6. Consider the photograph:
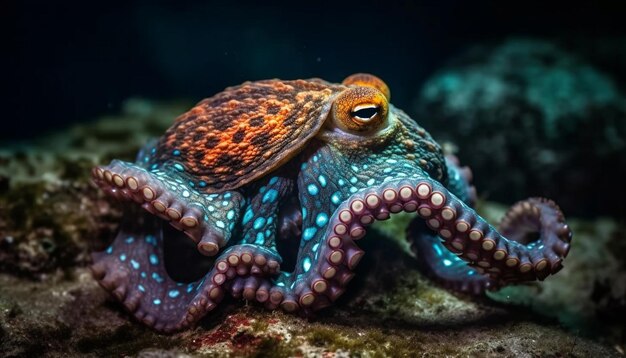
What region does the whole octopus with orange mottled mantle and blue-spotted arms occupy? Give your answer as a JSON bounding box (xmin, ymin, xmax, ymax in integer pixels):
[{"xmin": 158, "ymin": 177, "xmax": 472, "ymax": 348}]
[{"xmin": 91, "ymin": 74, "xmax": 572, "ymax": 332}]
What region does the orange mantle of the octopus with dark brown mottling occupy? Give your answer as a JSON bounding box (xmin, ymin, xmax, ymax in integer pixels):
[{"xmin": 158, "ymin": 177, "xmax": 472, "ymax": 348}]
[{"xmin": 158, "ymin": 79, "xmax": 345, "ymax": 191}]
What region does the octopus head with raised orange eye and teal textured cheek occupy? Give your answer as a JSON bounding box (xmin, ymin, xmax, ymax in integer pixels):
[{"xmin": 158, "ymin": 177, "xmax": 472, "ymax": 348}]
[{"xmin": 317, "ymin": 74, "xmax": 447, "ymax": 185}]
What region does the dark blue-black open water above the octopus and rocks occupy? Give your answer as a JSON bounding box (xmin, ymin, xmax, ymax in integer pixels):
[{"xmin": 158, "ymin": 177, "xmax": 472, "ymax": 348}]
[{"xmin": 0, "ymin": 0, "xmax": 626, "ymax": 143}]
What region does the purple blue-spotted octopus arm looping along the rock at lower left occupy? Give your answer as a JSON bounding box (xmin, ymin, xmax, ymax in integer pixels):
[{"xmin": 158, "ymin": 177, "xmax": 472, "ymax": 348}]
[{"xmin": 91, "ymin": 213, "xmax": 279, "ymax": 332}]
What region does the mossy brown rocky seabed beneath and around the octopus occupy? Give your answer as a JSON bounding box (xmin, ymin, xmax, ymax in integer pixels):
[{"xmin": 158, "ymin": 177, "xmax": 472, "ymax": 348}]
[{"xmin": 0, "ymin": 100, "xmax": 626, "ymax": 357}]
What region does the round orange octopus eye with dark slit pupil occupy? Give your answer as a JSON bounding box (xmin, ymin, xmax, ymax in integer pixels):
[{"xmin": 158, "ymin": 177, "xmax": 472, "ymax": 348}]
[{"xmin": 332, "ymin": 87, "xmax": 389, "ymax": 132}]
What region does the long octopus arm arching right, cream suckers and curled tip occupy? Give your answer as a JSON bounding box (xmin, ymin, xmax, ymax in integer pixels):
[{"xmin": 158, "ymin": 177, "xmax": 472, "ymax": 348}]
[{"xmin": 260, "ymin": 149, "xmax": 571, "ymax": 312}]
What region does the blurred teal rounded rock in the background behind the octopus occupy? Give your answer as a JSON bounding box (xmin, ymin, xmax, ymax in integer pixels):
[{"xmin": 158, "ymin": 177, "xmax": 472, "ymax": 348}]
[{"xmin": 416, "ymin": 39, "xmax": 626, "ymax": 217}]
